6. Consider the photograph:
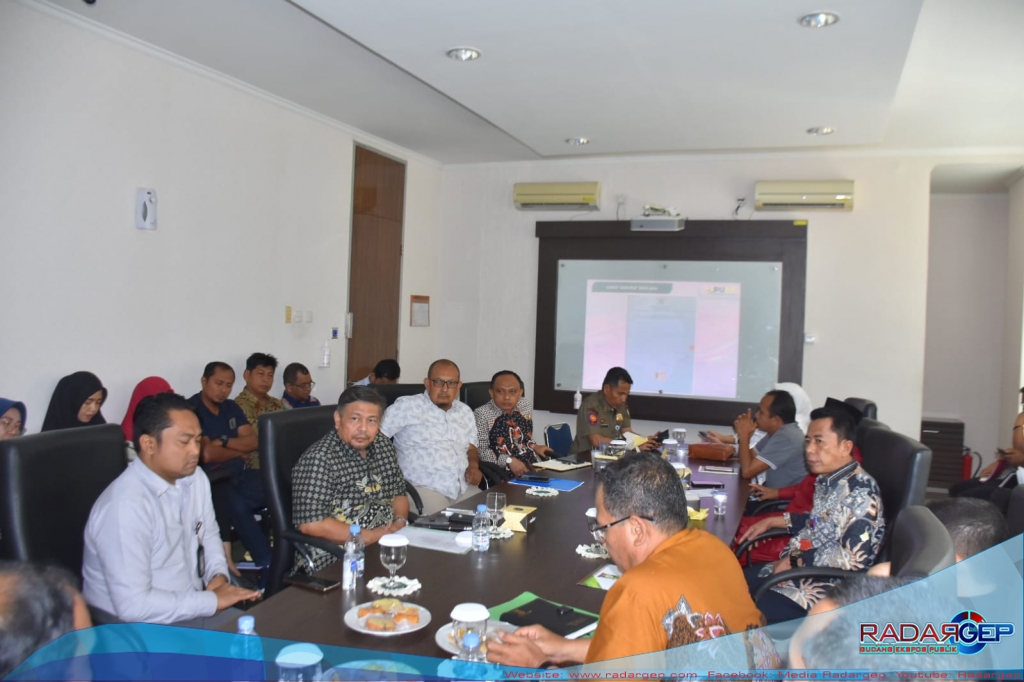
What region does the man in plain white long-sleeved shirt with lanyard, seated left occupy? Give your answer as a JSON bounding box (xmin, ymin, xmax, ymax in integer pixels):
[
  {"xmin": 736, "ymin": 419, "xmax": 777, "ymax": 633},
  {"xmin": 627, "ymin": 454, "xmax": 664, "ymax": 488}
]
[{"xmin": 82, "ymin": 393, "xmax": 259, "ymax": 626}]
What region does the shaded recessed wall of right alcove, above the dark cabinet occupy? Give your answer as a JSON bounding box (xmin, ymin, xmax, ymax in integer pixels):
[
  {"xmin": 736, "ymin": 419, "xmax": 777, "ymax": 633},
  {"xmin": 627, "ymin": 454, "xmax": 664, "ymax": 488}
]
[{"xmin": 923, "ymin": 194, "xmax": 1009, "ymax": 461}]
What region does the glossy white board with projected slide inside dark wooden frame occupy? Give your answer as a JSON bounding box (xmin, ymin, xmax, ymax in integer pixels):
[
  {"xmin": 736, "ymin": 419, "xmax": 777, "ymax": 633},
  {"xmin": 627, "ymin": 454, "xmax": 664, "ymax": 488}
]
[{"xmin": 555, "ymin": 260, "xmax": 781, "ymax": 400}]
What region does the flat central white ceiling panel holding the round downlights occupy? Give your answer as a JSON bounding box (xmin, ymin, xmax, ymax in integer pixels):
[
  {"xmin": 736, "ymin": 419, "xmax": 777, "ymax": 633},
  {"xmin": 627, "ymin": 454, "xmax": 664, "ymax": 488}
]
[{"xmin": 294, "ymin": 0, "xmax": 921, "ymax": 156}]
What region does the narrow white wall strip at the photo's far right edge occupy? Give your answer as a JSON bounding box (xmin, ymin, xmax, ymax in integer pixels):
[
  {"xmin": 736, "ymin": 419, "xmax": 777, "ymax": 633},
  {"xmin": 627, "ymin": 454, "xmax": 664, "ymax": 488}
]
[{"xmin": 999, "ymin": 178, "xmax": 1024, "ymax": 438}]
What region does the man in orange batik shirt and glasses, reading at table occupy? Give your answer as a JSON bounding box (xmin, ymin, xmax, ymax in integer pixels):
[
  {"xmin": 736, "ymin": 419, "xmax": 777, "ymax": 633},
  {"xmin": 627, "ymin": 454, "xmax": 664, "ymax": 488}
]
[{"xmin": 487, "ymin": 453, "xmax": 777, "ymax": 668}]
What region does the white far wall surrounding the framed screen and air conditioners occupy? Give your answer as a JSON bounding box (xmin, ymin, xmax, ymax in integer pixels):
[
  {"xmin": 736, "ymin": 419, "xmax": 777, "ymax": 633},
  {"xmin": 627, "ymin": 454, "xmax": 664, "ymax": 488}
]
[{"xmin": 438, "ymin": 155, "xmax": 1024, "ymax": 435}]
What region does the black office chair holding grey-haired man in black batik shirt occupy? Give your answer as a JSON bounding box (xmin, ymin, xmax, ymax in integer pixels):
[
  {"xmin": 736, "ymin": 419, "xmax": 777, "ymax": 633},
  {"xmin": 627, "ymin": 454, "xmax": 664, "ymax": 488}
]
[{"xmin": 259, "ymin": 404, "xmax": 423, "ymax": 597}]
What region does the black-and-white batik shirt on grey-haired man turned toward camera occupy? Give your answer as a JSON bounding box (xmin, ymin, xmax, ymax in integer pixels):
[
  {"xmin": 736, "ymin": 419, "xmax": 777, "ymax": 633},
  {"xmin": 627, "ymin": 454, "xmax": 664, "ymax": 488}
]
[{"xmin": 292, "ymin": 429, "xmax": 406, "ymax": 572}]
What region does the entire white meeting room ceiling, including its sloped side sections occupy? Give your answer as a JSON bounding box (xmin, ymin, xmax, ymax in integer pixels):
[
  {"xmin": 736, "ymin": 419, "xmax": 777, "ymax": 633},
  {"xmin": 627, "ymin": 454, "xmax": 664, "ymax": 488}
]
[{"xmin": 49, "ymin": 0, "xmax": 1024, "ymax": 163}]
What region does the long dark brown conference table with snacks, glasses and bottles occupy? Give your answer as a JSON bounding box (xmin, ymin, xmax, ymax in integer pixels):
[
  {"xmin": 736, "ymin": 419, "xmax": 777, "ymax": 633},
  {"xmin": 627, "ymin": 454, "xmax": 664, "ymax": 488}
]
[{"xmin": 222, "ymin": 461, "xmax": 749, "ymax": 659}]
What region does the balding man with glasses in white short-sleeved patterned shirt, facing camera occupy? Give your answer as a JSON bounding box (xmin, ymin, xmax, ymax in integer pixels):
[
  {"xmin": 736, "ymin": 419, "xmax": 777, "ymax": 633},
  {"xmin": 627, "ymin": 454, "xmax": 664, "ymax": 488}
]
[{"xmin": 381, "ymin": 359, "xmax": 483, "ymax": 514}]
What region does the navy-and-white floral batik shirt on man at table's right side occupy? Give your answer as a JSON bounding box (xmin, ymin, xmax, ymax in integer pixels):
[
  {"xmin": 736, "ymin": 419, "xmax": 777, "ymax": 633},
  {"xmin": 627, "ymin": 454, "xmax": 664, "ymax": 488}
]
[{"xmin": 772, "ymin": 461, "xmax": 886, "ymax": 609}]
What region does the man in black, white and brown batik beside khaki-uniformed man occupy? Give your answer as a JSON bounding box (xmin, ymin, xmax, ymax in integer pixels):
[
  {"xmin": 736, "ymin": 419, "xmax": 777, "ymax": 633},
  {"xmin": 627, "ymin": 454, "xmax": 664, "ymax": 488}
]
[{"xmin": 473, "ymin": 370, "xmax": 552, "ymax": 476}]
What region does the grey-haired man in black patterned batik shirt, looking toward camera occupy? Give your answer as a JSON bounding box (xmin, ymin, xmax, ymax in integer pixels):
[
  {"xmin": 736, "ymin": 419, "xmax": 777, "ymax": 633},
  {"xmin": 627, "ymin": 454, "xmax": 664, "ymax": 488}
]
[{"xmin": 292, "ymin": 386, "xmax": 409, "ymax": 572}]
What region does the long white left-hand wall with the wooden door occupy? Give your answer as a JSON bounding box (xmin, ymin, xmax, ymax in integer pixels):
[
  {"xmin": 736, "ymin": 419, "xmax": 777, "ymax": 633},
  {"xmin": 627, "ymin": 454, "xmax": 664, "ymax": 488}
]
[{"xmin": 0, "ymin": 2, "xmax": 440, "ymax": 431}]
